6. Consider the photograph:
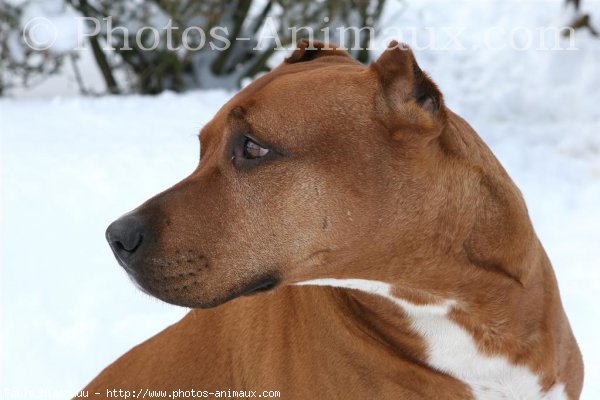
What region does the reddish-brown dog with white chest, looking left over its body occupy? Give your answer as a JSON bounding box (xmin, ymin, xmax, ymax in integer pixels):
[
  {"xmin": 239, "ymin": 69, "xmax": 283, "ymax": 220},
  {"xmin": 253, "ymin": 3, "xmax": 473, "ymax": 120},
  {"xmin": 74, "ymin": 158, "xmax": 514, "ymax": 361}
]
[{"xmin": 87, "ymin": 42, "xmax": 583, "ymax": 399}]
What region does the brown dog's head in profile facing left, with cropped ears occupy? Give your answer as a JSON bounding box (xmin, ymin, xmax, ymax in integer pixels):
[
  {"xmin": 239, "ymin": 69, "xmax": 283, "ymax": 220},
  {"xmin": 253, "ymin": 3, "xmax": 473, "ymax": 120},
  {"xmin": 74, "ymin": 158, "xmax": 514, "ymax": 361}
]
[{"xmin": 107, "ymin": 41, "xmax": 528, "ymax": 308}]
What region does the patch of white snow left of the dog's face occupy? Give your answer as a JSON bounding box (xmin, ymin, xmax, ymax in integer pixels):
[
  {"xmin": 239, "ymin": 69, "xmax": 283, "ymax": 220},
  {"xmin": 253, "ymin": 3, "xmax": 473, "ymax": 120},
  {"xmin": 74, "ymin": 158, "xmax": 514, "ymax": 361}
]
[{"xmin": 0, "ymin": 92, "xmax": 229, "ymax": 398}]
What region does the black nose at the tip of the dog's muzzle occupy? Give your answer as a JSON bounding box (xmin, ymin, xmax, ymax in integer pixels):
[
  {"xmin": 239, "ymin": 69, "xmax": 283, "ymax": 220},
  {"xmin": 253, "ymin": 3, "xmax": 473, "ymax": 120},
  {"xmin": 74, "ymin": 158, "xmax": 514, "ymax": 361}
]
[{"xmin": 106, "ymin": 215, "xmax": 147, "ymax": 264}]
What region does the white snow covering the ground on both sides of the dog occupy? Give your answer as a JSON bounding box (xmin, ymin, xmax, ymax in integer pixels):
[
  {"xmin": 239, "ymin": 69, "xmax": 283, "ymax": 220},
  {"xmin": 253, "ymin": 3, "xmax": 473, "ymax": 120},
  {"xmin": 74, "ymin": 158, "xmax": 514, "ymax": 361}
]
[{"xmin": 0, "ymin": 2, "xmax": 600, "ymax": 399}]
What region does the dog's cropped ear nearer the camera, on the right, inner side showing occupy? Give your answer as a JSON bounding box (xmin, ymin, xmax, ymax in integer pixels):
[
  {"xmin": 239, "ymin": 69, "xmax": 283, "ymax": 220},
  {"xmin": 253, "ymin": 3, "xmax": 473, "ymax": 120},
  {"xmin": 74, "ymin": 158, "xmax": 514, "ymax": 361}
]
[{"xmin": 371, "ymin": 40, "xmax": 444, "ymax": 119}]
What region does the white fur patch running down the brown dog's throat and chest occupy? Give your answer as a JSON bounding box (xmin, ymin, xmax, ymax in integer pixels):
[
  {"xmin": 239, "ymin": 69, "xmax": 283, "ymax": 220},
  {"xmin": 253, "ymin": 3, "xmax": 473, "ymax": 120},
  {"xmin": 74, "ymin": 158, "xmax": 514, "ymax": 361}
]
[{"xmin": 297, "ymin": 279, "xmax": 568, "ymax": 400}]
